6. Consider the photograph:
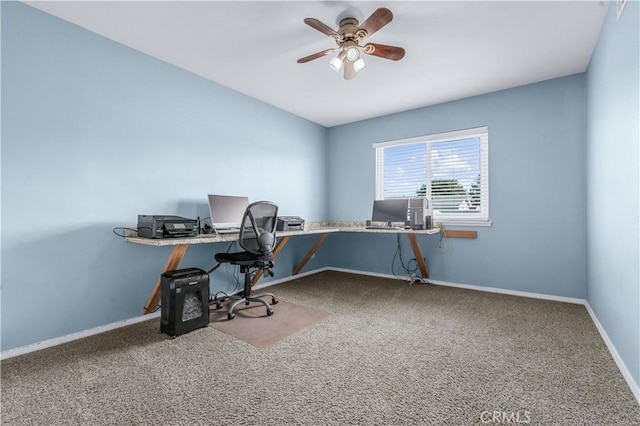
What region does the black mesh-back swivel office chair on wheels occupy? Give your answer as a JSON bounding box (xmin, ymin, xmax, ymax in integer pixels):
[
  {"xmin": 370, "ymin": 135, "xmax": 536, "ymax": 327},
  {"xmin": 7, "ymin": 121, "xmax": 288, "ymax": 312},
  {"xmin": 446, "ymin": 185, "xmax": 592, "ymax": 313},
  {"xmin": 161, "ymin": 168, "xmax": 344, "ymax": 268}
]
[{"xmin": 215, "ymin": 201, "xmax": 278, "ymax": 320}]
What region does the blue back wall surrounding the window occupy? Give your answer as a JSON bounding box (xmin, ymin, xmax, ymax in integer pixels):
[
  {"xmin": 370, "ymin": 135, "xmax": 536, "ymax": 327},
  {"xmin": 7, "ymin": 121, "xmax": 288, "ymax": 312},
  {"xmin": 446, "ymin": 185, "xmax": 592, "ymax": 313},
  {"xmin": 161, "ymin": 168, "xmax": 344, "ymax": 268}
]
[{"xmin": 328, "ymin": 74, "xmax": 586, "ymax": 298}]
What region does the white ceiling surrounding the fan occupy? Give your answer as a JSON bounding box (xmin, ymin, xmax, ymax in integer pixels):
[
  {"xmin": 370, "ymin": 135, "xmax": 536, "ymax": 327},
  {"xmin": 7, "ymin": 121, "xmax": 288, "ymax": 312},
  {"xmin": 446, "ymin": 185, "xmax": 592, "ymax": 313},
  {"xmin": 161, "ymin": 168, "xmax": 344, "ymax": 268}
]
[{"xmin": 26, "ymin": 1, "xmax": 608, "ymax": 127}]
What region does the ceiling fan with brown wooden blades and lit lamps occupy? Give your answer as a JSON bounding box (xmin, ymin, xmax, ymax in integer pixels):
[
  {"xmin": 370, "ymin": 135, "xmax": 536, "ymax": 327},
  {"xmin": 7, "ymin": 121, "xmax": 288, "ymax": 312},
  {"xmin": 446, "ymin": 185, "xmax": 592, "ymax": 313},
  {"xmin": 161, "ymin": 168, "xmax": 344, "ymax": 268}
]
[{"xmin": 297, "ymin": 7, "xmax": 404, "ymax": 80}]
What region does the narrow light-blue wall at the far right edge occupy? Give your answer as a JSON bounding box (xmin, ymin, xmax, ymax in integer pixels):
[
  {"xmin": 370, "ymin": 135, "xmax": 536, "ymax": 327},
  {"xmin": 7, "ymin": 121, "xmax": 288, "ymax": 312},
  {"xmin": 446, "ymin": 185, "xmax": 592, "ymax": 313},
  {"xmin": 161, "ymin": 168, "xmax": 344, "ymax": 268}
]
[{"xmin": 587, "ymin": 1, "xmax": 640, "ymax": 387}]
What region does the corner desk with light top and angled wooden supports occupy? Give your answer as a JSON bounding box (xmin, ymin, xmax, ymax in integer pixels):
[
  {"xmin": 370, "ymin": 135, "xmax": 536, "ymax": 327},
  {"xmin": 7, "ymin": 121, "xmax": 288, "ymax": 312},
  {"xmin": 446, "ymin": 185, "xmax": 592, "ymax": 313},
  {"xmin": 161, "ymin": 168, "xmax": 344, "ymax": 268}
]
[{"xmin": 125, "ymin": 225, "xmax": 439, "ymax": 315}]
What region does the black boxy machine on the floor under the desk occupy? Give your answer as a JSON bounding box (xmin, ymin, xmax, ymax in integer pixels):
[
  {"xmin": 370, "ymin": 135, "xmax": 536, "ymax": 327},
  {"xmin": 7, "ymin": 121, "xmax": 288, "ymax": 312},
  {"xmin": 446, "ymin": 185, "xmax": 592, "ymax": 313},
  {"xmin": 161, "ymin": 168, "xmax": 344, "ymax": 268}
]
[{"xmin": 160, "ymin": 268, "xmax": 209, "ymax": 337}]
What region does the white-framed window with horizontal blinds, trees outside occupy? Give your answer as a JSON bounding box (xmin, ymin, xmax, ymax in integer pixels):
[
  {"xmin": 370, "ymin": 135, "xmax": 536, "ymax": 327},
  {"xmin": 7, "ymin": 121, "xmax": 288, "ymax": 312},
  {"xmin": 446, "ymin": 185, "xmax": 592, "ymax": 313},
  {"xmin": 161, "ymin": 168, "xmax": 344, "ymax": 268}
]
[{"xmin": 373, "ymin": 127, "xmax": 490, "ymax": 225}]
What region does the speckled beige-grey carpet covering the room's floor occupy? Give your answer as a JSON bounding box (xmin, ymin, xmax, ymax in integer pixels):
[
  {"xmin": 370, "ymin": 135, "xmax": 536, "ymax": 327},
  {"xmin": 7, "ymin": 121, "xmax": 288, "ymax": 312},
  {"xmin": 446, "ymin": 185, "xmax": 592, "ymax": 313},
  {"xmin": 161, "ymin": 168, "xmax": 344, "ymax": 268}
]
[{"xmin": 0, "ymin": 271, "xmax": 640, "ymax": 426}]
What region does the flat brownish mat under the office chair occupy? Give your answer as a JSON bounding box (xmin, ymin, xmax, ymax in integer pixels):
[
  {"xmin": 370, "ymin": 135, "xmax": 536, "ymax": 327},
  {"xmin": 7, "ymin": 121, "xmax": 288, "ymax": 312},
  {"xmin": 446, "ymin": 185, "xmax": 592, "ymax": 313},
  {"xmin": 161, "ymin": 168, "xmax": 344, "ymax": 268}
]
[{"xmin": 209, "ymin": 300, "xmax": 331, "ymax": 348}]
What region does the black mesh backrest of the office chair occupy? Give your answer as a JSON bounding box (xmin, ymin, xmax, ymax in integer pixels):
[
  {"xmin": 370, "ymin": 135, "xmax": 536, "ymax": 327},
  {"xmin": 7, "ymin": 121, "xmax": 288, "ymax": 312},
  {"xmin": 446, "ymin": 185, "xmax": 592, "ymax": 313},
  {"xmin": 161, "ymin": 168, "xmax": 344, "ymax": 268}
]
[{"xmin": 239, "ymin": 201, "xmax": 278, "ymax": 260}]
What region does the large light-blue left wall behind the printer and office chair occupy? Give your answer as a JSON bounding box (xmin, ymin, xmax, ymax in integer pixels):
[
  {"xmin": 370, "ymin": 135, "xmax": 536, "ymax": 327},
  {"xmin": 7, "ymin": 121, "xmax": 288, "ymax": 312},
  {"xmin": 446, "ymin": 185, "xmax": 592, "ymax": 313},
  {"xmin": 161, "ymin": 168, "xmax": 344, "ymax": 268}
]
[{"xmin": 1, "ymin": 2, "xmax": 327, "ymax": 350}]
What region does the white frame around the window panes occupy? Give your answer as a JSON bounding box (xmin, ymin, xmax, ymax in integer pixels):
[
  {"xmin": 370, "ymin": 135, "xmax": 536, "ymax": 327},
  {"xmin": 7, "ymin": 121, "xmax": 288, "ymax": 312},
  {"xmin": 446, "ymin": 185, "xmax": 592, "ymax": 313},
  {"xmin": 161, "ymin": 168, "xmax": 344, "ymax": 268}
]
[{"xmin": 373, "ymin": 126, "xmax": 491, "ymax": 226}]
